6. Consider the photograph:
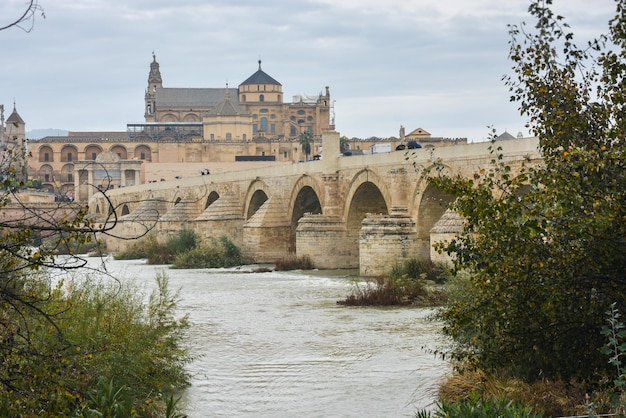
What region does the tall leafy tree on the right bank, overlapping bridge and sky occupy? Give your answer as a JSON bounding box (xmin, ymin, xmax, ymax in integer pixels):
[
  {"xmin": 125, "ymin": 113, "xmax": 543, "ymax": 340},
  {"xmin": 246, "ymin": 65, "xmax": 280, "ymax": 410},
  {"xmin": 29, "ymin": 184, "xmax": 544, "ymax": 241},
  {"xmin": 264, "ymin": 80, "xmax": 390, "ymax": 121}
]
[{"xmin": 429, "ymin": 0, "xmax": 626, "ymax": 384}]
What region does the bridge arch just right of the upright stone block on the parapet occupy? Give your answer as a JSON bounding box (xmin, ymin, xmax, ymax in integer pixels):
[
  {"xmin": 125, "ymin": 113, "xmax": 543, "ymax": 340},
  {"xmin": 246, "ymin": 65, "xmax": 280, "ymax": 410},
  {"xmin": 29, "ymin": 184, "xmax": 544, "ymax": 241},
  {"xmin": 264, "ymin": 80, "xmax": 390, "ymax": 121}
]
[{"xmin": 344, "ymin": 169, "xmax": 391, "ymax": 266}]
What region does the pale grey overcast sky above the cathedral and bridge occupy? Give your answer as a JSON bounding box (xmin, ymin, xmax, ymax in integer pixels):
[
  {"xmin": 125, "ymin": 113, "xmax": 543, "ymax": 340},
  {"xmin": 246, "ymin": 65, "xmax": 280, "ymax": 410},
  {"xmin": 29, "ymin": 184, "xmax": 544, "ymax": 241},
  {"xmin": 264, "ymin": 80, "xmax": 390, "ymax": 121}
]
[{"xmin": 0, "ymin": 0, "xmax": 615, "ymax": 141}]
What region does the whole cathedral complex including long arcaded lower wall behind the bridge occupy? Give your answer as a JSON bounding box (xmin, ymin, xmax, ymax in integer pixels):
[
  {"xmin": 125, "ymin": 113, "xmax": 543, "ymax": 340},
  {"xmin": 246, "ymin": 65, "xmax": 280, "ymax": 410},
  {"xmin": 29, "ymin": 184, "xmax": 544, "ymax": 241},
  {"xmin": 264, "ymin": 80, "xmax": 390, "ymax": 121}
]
[{"xmin": 28, "ymin": 54, "xmax": 334, "ymax": 200}]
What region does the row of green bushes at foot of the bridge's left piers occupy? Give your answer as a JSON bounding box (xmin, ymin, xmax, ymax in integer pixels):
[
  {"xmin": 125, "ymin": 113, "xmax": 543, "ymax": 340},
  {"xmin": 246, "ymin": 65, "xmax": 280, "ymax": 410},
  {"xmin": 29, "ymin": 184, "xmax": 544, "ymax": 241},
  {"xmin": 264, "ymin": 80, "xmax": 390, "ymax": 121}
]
[{"xmin": 115, "ymin": 229, "xmax": 245, "ymax": 269}]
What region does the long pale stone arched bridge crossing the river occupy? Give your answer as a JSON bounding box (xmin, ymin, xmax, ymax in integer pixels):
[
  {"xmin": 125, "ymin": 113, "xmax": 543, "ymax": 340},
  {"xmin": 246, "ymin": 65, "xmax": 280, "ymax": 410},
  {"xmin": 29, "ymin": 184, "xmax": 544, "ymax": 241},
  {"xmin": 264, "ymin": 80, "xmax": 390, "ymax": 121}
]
[{"xmin": 89, "ymin": 132, "xmax": 541, "ymax": 276}]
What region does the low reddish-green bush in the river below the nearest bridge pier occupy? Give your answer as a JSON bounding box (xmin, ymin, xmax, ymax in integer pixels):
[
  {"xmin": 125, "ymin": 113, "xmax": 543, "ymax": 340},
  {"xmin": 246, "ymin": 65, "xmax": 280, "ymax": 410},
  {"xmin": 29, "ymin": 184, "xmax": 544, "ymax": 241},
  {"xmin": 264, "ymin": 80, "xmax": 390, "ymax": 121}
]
[{"xmin": 337, "ymin": 259, "xmax": 447, "ymax": 306}]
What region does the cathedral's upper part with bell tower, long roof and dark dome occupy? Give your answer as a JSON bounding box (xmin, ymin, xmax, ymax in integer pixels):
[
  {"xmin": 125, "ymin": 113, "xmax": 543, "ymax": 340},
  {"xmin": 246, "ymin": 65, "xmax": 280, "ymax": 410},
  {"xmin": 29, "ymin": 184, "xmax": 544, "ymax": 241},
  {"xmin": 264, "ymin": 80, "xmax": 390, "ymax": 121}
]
[{"xmin": 144, "ymin": 55, "xmax": 331, "ymax": 142}]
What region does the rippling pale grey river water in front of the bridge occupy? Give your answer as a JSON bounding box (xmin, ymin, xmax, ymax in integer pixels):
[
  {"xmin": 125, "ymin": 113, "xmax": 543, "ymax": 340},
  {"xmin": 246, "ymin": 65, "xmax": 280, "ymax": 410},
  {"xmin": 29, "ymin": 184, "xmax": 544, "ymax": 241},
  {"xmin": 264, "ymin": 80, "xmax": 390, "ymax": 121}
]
[{"xmin": 84, "ymin": 259, "xmax": 449, "ymax": 418}]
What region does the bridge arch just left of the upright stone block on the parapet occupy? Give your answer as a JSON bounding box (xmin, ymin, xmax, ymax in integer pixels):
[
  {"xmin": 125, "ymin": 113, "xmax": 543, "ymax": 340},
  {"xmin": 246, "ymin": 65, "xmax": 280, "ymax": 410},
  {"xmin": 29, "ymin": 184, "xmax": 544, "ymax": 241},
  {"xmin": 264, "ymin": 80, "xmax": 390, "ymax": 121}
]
[{"xmin": 288, "ymin": 175, "xmax": 324, "ymax": 253}]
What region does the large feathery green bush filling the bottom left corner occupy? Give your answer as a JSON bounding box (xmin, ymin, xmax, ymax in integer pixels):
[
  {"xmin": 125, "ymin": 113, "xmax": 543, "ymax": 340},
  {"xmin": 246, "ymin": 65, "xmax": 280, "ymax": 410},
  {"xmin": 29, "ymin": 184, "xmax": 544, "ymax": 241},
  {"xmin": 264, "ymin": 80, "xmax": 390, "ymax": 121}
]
[{"xmin": 0, "ymin": 274, "xmax": 191, "ymax": 417}]
